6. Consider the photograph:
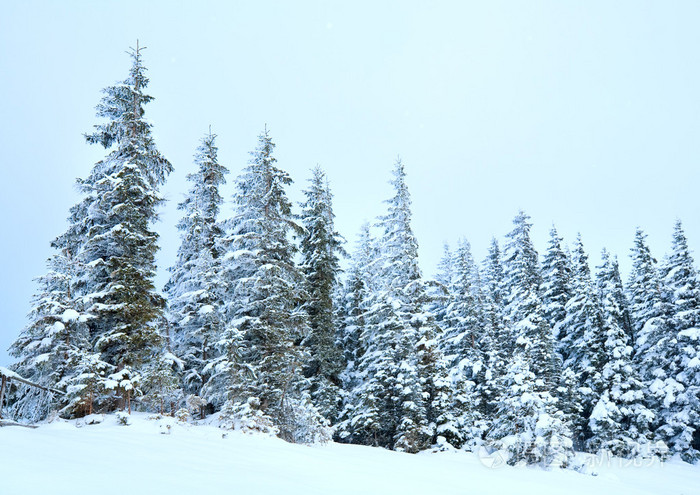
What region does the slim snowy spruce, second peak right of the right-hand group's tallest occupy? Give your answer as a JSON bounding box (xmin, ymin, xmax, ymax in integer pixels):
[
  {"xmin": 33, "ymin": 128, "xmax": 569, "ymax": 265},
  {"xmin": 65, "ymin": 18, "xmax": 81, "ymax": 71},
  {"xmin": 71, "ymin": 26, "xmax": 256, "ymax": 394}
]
[{"xmin": 560, "ymin": 235, "xmax": 605, "ymax": 445}]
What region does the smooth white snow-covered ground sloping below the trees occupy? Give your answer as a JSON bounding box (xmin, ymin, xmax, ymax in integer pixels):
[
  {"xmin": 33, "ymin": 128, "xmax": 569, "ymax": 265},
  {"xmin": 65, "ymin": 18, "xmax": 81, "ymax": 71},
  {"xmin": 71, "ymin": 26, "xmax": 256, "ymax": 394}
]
[{"xmin": 0, "ymin": 414, "xmax": 700, "ymax": 495}]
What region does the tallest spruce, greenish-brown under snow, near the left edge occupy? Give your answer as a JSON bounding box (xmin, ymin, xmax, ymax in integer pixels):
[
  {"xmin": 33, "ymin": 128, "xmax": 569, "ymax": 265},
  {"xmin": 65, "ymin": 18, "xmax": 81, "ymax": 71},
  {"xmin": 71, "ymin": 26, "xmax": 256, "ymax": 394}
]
[{"xmin": 54, "ymin": 45, "xmax": 172, "ymax": 412}]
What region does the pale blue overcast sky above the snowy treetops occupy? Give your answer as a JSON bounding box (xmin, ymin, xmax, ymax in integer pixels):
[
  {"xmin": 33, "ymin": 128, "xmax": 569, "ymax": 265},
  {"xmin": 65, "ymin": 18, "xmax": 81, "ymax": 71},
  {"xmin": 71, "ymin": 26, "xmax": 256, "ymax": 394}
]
[{"xmin": 0, "ymin": 0, "xmax": 700, "ymax": 365}]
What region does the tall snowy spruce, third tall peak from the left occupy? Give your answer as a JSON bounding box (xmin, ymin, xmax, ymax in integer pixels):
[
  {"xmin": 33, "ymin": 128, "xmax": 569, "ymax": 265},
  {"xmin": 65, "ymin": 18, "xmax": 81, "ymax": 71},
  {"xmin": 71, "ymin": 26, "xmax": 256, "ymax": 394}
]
[{"xmin": 223, "ymin": 129, "xmax": 325, "ymax": 441}]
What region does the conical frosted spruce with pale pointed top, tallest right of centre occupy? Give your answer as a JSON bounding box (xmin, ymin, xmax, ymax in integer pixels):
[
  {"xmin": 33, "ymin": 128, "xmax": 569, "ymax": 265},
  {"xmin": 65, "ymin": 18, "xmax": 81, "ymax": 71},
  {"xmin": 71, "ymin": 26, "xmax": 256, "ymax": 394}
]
[{"xmin": 340, "ymin": 160, "xmax": 451, "ymax": 452}]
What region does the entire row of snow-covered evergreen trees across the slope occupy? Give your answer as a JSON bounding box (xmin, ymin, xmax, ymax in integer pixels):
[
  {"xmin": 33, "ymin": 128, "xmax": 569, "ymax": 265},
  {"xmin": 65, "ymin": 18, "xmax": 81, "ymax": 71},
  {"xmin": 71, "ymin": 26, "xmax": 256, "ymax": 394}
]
[{"xmin": 5, "ymin": 47, "xmax": 700, "ymax": 465}]
